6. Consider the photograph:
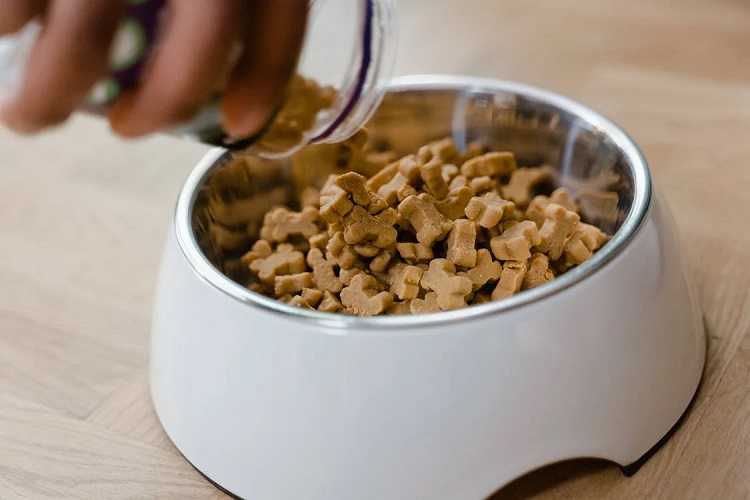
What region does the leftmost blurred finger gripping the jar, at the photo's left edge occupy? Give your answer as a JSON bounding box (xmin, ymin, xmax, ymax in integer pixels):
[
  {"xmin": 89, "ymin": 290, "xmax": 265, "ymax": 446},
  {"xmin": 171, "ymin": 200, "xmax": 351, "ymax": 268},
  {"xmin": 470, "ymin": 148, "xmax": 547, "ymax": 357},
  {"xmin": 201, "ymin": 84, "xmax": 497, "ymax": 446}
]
[{"xmin": 0, "ymin": 0, "xmax": 124, "ymax": 133}]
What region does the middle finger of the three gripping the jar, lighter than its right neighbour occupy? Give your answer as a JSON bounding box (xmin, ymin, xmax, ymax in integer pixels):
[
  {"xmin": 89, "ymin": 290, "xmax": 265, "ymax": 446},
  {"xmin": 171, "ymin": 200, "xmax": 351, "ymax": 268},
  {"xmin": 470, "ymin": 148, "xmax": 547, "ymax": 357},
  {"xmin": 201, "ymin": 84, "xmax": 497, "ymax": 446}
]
[{"xmin": 110, "ymin": 0, "xmax": 246, "ymax": 137}]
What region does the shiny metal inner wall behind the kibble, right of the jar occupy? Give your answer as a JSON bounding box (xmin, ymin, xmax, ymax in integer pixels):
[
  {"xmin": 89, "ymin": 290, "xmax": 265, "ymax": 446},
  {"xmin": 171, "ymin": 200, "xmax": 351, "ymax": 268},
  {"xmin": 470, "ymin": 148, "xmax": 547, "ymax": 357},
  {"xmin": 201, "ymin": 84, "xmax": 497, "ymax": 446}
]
[{"xmin": 368, "ymin": 83, "xmax": 636, "ymax": 235}]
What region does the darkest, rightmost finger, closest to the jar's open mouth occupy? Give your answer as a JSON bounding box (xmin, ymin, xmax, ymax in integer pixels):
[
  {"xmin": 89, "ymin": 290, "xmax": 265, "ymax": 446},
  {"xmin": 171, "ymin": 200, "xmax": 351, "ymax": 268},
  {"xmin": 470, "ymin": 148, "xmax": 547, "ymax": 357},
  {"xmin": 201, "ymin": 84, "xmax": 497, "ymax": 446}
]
[{"xmin": 222, "ymin": 0, "xmax": 308, "ymax": 138}]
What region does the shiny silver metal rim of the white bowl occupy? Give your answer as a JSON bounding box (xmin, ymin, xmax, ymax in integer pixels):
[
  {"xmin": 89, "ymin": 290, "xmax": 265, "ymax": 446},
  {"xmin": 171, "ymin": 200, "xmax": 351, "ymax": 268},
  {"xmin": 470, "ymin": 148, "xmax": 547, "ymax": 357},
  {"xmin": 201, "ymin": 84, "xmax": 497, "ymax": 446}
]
[{"xmin": 174, "ymin": 75, "xmax": 652, "ymax": 333}]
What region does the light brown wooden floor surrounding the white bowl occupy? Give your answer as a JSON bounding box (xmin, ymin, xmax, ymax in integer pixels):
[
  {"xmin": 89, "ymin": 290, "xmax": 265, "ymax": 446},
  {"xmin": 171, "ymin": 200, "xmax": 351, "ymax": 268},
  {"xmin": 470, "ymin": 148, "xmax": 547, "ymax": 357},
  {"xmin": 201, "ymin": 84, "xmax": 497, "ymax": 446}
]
[{"xmin": 0, "ymin": 0, "xmax": 750, "ymax": 499}]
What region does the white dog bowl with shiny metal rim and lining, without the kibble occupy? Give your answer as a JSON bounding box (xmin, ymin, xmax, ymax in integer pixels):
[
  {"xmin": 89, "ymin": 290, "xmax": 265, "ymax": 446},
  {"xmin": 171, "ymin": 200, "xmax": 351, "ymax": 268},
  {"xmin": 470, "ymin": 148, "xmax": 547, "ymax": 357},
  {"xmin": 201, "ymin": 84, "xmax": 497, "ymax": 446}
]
[{"xmin": 151, "ymin": 77, "xmax": 705, "ymax": 500}]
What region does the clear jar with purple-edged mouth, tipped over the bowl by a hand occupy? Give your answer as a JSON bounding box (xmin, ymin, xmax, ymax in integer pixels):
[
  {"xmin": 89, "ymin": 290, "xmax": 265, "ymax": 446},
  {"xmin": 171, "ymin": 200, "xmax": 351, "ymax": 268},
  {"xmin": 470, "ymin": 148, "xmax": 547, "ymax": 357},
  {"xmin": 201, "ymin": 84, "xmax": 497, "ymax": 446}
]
[{"xmin": 0, "ymin": 0, "xmax": 395, "ymax": 158}]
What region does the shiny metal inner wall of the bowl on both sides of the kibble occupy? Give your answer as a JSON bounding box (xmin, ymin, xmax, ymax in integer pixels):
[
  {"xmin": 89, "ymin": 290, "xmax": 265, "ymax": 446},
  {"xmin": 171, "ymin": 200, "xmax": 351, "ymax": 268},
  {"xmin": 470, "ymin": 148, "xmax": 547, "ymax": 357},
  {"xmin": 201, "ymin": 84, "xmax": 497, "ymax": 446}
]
[{"xmin": 178, "ymin": 78, "xmax": 650, "ymax": 322}]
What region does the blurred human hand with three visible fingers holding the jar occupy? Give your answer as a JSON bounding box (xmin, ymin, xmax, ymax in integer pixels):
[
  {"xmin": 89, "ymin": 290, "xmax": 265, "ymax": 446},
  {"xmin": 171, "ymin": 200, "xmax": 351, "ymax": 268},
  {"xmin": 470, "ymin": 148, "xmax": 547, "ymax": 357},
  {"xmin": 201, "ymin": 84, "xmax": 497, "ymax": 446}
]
[{"xmin": 0, "ymin": 0, "xmax": 308, "ymax": 137}]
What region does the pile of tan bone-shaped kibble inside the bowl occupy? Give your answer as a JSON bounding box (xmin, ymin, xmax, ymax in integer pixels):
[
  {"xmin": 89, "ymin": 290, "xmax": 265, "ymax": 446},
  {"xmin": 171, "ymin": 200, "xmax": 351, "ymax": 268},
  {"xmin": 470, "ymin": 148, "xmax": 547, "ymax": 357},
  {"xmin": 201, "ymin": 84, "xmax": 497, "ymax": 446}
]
[{"xmin": 222, "ymin": 137, "xmax": 611, "ymax": 316}]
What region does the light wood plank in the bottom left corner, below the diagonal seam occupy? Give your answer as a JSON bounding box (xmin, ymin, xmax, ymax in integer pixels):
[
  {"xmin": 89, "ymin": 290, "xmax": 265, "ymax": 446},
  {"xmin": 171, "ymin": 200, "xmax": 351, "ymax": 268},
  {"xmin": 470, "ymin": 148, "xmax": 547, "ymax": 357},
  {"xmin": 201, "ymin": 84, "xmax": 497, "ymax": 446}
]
[{"xmin": 0, "ymin": 394, "xmax": 217, "ymax": 499}]
